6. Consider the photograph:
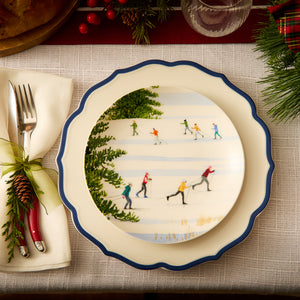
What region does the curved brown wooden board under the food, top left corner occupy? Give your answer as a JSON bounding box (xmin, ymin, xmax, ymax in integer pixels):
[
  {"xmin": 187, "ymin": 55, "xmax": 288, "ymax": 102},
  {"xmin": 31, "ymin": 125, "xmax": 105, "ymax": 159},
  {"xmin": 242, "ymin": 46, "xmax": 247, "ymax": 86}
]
[{"xmin": 0, "ymin": 0, "xmax": 78, "ymax": 57}]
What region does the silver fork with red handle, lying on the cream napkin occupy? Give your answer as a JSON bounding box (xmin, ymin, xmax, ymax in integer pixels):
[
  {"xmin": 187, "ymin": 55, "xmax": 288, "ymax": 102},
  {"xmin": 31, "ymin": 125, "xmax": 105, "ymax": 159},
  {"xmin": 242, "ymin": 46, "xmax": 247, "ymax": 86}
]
[{"xmin": 15, "ymin": 84, "xmax": 46, "ymax": 252}]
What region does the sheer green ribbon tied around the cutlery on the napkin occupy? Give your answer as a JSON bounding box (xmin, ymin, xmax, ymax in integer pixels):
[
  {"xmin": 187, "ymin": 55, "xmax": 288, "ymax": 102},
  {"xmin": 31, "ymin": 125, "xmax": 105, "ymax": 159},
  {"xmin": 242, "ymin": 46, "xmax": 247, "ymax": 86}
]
[{"xmin": 0, "ymin": 138, "xmax": 62, "ymax": 212}]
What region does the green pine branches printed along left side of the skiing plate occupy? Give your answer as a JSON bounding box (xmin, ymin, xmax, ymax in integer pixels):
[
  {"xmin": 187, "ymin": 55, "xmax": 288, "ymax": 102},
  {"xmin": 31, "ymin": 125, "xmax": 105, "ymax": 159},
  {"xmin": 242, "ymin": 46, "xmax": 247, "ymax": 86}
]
[{"xmin": 85, "ymin": 86, "xmax": 163, "ymax": 222}]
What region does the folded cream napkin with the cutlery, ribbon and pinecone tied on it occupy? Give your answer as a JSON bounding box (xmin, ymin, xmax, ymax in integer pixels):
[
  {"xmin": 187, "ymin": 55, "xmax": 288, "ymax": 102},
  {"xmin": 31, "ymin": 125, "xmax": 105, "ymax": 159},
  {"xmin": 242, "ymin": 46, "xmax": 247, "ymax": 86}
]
[{"xmin": 0, "ymin": 69, "xmax": 73, "ymax": 272}]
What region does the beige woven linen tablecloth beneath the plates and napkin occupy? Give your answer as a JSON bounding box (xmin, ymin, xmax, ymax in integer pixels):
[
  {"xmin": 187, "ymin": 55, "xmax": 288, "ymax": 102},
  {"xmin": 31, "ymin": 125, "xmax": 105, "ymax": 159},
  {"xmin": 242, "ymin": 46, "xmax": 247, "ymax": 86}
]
[{"xmin": 0, "ymin": 44, "xmax": 300, "ymax": 294}]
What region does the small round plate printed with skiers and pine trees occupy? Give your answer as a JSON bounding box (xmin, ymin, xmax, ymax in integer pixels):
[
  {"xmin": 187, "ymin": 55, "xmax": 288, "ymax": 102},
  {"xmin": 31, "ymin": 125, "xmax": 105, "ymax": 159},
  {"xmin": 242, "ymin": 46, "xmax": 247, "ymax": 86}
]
[{"xmin": 85, "ymin": 86, "xmax": 244, "ymax": 243}]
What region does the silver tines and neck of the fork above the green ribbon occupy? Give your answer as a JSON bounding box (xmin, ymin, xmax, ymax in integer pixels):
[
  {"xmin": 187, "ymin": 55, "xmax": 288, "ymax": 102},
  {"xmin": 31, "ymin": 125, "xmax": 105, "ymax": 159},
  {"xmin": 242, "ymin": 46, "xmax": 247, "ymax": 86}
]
[{"xmin": 15, "ymin": 84, "xmax": 37, "ymax": 154}]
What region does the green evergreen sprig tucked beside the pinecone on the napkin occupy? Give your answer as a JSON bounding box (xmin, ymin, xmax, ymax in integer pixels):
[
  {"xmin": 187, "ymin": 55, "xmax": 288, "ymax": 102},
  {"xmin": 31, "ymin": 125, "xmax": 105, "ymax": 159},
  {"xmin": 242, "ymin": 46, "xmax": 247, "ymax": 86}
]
[{"xmin": 1, "ymin": 172, "xmax": 31, "ymax": 262}]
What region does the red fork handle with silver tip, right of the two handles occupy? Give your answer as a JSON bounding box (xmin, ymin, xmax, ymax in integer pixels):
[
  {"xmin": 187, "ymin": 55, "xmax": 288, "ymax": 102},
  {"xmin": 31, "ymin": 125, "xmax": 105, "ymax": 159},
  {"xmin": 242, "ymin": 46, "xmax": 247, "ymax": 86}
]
[{"xmin": 27, "ymin": 195, "xmax": 46, "ymax": 252}]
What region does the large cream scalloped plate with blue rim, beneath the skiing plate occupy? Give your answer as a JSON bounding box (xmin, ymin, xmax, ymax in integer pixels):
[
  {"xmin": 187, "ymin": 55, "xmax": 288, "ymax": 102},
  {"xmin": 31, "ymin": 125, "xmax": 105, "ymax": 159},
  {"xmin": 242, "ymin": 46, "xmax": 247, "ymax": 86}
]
[{"xmin": 57, "ymin": 60, "xmax": 274, "ymax": 270}]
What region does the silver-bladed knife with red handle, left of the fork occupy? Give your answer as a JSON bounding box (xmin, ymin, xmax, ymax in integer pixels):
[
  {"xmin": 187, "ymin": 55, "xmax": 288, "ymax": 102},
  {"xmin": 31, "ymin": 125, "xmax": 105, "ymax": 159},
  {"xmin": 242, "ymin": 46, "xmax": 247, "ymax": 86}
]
[{"xmin": 8, "ymin": 81, "xmax": 30, "ymax": 257}]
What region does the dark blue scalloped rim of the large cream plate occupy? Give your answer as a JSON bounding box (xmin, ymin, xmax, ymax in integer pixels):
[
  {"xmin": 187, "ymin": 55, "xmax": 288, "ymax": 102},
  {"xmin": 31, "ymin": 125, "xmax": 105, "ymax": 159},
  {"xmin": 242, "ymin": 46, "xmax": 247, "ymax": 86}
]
[{"xmin": 56, "ymin": 59, "xmax": 274, "ymax": 271}]
